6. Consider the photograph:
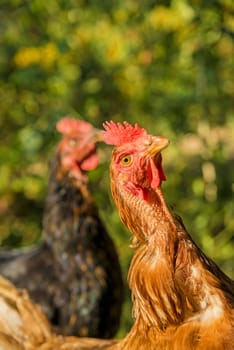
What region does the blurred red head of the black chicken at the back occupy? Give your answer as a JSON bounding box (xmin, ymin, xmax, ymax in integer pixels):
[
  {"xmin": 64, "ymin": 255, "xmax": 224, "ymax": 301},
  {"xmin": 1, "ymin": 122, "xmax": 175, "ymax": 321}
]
[{"xmin": 56, "ymin": 117, "xmax": 100, "ymax": 177}]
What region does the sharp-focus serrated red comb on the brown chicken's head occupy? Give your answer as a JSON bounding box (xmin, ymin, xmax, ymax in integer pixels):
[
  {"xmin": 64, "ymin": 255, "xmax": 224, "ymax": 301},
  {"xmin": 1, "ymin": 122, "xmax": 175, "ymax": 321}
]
[{"xmin": 103, "ymin": 120, "xmax": 147, "ymax": 146}]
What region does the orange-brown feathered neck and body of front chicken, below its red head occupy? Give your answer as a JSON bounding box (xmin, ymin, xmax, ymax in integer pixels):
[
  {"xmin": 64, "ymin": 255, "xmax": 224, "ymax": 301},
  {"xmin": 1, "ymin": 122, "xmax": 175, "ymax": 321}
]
[{"xmin": 112, "ymin": 187, "xmax": 234, "ymax": 350}]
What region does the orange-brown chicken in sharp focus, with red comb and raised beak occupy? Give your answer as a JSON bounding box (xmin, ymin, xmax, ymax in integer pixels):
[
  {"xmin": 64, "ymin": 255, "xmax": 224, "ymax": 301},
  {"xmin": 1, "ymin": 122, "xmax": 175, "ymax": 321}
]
[{"xmin": 103, "ymin": 122, "xmax": 234, "ymax": 350}]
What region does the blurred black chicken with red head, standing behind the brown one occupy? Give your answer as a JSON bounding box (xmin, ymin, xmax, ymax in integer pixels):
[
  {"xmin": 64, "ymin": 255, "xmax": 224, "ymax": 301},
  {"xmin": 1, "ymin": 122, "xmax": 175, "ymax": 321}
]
[{"xmin": 0, "ymin": 117, "xmax": 123, "ymax": 338}]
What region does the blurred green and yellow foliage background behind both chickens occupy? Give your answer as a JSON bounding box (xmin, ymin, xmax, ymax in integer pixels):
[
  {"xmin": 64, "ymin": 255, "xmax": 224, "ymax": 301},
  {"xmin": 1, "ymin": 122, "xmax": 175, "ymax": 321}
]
[{"xmin": 0, "ymin": 0, "xmax": 234, "ymax": 336}]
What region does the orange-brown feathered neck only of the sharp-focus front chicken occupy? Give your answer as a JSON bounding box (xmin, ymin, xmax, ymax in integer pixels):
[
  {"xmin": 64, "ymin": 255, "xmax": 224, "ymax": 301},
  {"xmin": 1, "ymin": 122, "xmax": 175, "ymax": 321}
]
[{"xmin": 111, "ymin": 181, "xmax": 183, "ymax": 331}]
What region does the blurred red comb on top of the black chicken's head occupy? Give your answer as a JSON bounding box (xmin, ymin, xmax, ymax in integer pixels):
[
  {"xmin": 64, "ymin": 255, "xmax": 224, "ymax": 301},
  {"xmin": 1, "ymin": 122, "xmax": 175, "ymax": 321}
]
[{"xmin": 56, "ymin": 117, "xmax": 92, "ymax": 135}]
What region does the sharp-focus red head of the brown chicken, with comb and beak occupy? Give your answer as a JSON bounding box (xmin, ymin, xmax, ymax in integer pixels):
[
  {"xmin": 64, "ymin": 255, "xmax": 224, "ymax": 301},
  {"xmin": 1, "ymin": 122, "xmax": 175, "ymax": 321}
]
[{"xmin": 103, "ymin": 121, "xmax": 169, "ymax": 199}]
